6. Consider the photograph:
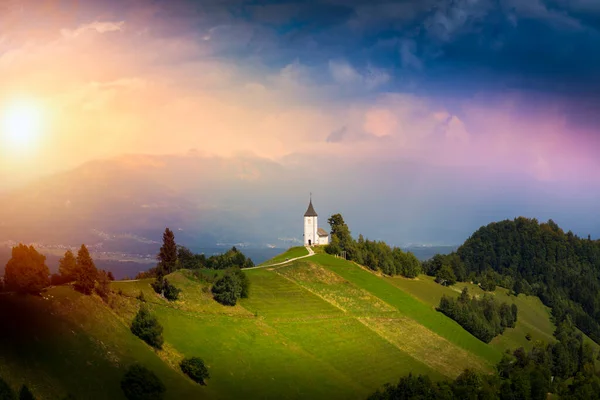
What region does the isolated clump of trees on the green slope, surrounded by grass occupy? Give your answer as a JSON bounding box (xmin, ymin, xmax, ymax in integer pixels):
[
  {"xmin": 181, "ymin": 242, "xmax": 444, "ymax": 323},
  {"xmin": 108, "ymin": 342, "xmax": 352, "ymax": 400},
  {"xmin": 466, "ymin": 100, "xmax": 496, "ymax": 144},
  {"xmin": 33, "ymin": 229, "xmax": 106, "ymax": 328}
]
[{"xmin": 437, "ymin": 288, "xmax": 517, "ymax": 343}]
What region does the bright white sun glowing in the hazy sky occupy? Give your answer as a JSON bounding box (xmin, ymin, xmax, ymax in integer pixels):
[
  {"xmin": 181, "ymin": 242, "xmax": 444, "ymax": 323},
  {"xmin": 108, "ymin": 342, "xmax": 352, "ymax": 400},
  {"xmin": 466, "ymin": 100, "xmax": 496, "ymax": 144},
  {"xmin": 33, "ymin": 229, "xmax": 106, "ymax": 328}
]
[{"xmin": 0, "ymin": 101, "xmax": 42, "ymax": 150}]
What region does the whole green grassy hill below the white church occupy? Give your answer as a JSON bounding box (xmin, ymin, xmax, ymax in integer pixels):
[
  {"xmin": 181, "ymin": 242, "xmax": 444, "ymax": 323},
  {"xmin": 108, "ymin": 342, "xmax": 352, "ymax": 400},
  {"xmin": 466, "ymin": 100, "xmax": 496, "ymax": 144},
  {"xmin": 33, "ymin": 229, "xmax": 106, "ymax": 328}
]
[{"xmin": 0, "ymin": 252, "xmax": 554, "ymax": 399}]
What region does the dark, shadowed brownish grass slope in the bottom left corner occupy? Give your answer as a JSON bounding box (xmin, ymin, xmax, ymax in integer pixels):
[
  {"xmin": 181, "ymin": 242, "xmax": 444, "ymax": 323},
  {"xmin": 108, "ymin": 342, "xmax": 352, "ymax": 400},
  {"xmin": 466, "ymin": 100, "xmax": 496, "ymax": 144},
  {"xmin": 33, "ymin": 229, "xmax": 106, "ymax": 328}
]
[{"xmin": 0, "ymin": 287, "xmax": 204, "ymax": 399}]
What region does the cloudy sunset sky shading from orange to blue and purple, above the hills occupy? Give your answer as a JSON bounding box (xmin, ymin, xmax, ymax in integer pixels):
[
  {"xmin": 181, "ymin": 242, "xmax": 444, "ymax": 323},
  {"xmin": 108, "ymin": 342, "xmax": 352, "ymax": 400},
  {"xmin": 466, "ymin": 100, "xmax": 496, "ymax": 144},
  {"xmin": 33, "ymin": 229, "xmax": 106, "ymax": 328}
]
[{"xmin": 0, "ymin": 0, "xmax": 600, "ymax": 245}]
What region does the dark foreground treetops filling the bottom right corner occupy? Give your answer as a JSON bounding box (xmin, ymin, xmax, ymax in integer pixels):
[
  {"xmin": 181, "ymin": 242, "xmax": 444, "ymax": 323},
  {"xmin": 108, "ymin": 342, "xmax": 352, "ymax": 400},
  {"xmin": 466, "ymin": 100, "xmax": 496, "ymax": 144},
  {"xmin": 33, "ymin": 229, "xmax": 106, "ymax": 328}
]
[{"xmin": 369, "ymin": 317, "xmax": 600, "ymax": 400}]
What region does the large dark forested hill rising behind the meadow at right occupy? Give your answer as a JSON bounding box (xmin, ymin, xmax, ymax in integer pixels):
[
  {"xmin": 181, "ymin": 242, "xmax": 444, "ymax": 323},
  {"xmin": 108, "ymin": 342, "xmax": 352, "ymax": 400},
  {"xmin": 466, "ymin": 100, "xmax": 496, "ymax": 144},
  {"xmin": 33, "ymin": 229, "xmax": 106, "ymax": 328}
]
[{"xmin": 432, "ymin": 217, "xmax": 600, "ymax": 343}]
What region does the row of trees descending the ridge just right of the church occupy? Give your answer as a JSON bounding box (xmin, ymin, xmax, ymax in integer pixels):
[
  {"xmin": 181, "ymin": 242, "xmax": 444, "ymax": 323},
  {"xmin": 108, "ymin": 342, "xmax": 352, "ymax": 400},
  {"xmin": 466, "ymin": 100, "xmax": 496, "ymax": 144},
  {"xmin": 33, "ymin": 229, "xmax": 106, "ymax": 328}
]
[{"xmin": 325, "ymin": 214, "xmax": 421, "ymax": 278}]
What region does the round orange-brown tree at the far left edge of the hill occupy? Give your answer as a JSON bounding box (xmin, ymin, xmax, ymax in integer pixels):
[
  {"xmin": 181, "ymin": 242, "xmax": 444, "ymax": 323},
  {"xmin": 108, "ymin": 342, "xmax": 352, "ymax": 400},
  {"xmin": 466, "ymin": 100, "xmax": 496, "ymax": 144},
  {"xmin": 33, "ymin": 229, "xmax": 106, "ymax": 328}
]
[{"xmin": 4, "ymin": 244, "xmax": 50, "ymax": 293}]
